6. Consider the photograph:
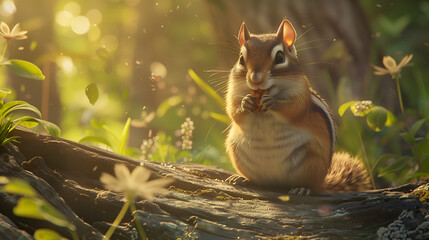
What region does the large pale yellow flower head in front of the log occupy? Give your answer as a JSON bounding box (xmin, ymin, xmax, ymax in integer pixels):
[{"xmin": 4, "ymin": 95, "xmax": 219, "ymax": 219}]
[{"xmin": 100, "ymin": 164, "xmax": 173, "ymax": 200}]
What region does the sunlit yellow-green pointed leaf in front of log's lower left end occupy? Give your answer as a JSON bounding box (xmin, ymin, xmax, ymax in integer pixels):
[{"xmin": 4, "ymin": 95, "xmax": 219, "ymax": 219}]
[{"xmin": 13, "ymin": 197, "xmax": 76, "ymax": 230}]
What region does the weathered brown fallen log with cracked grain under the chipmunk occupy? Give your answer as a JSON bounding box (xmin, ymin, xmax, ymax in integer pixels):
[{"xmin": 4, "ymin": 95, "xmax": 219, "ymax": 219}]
[{"xmin": 0, "ymin": 129, "xmax": 429, "ymax": 239}]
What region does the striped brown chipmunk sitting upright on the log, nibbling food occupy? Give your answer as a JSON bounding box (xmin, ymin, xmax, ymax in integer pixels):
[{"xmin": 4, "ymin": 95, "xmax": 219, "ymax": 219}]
[{"xmin": 225, "ymin": 20, "xmax": 371, "ymax": 194}]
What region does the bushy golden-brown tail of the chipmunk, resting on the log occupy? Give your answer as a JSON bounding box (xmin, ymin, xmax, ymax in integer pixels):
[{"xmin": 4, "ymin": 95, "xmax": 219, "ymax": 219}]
[{"xmin": 324, "ymin": 152, "xmax": 372, "ymax": 193}]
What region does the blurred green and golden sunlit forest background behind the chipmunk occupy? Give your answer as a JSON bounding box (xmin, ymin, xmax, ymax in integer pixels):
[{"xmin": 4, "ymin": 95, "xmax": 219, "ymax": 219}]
[{"xmin": 0, "ymin": 0, "xmax": 429, "ymax": 185}]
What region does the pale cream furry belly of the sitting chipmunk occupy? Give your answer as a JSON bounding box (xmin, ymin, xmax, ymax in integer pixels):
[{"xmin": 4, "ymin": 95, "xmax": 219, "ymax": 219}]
[{"xmin": 227, "ymin": 113, "xmax": 311, "ymax": 186}]
